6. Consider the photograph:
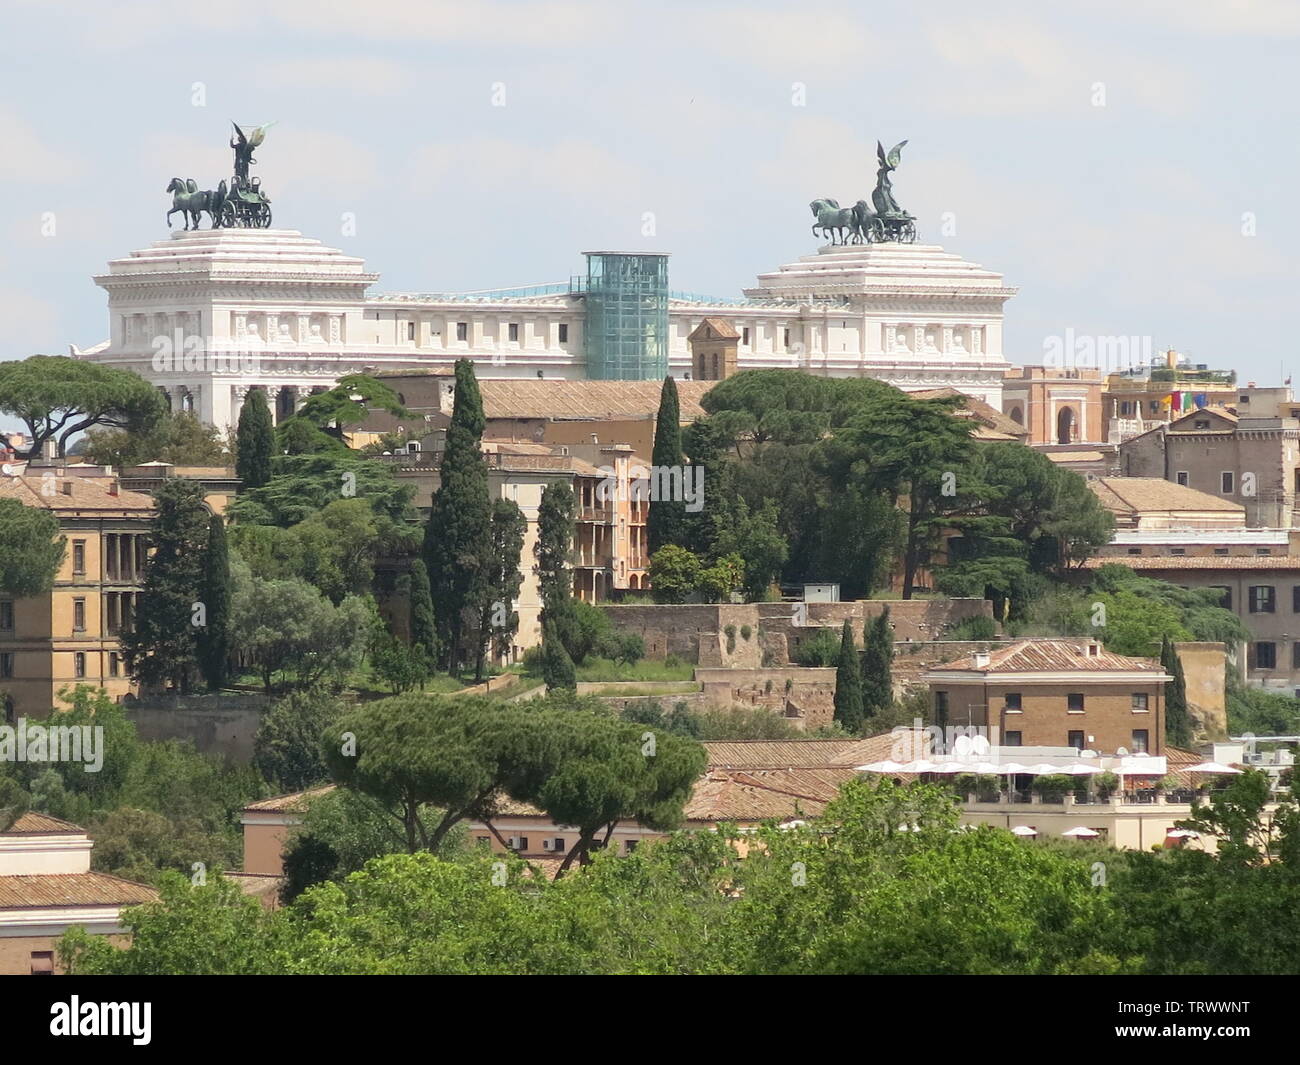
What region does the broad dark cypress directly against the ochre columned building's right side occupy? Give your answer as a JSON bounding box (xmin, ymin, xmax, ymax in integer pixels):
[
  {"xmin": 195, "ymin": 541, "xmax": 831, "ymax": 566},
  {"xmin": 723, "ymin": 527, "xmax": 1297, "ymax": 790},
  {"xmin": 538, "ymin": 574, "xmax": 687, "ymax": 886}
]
[{"xmin": 122, "ymin": 479, "xmax": 209, "ymax": 692}]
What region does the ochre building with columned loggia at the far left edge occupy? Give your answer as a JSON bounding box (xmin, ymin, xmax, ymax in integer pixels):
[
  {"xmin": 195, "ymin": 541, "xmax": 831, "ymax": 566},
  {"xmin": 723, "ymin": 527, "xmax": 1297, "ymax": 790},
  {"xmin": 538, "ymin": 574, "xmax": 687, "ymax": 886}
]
[{"xmin": 0, "ymin": 466, "xmax": 153, "ymax": 717}]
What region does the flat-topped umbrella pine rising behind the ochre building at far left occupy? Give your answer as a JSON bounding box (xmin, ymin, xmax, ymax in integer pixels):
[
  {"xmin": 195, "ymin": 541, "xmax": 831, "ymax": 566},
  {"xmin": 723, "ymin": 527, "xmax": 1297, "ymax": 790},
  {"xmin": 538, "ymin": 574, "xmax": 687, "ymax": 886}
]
[{"xmin": 0, "ymin": 355, "xmax": 166, "ymax": 458}]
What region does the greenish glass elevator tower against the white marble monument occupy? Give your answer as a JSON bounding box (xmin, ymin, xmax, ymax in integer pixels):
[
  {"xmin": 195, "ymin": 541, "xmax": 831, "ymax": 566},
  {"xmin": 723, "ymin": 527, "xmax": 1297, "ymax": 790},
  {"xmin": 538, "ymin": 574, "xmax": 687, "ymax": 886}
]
[{"xmin": 582, "ymin": 251, "xmax": 668, "ymax": 381}]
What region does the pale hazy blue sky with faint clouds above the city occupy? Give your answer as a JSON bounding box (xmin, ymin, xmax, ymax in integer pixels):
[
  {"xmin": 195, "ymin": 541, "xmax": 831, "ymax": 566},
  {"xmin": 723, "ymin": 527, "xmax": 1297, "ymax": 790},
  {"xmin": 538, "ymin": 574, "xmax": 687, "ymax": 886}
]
[{"xmin": 0, "ymin": 0, "xmax": 1300, "ymax": 384}]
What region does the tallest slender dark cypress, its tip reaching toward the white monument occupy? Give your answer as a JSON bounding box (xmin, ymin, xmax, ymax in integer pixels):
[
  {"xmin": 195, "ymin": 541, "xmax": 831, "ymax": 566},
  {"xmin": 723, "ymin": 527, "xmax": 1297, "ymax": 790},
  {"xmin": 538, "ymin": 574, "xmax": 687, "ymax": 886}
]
[{"xmin": 424, "ymin": 359, "xmax": 491, "ymax": 674}]
